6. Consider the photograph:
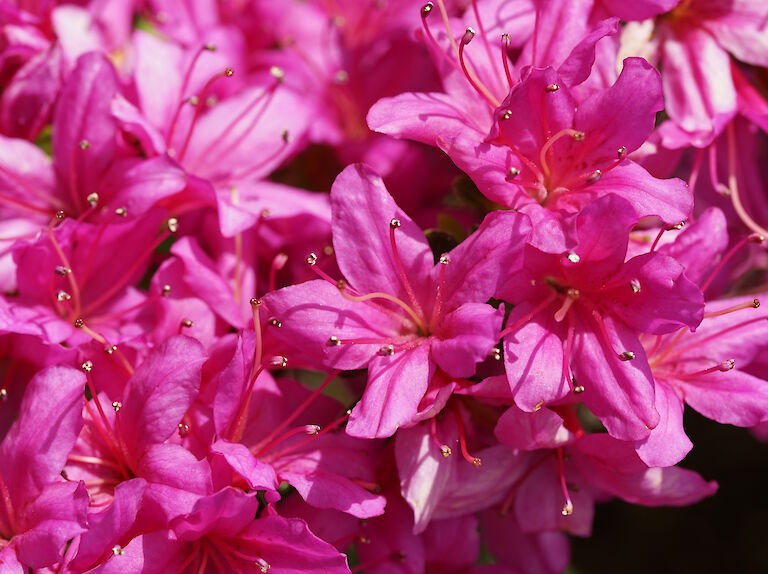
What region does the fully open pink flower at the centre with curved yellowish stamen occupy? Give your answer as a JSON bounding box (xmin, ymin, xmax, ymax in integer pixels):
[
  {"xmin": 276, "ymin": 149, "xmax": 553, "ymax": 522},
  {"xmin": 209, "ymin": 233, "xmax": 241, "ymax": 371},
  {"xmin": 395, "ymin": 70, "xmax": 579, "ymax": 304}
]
[{"xmin": 264, "ymin": 165, "xmax": 529, "ymax": 437}]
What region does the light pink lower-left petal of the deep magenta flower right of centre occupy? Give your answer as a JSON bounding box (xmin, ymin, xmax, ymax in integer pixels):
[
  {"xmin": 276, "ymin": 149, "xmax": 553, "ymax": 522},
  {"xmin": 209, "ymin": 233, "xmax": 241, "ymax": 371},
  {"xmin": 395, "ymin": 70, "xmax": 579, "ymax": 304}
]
[{"xmin": 504, "ymin": 302, "xmax": 570, "ymax": 412}]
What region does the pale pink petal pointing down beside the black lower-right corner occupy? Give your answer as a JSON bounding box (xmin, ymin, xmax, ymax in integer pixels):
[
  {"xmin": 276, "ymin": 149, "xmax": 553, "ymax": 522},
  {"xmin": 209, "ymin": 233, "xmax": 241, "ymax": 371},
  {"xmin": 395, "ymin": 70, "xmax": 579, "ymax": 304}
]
[{"xmin": 635, "ymin": 383, "xmax": 693, "ymax": 466}]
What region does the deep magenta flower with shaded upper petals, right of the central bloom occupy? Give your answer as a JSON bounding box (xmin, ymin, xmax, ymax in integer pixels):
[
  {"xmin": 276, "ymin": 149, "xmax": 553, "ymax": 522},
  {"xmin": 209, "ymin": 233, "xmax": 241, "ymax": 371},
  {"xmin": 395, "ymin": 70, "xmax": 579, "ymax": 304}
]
[{"xmin": 498, "ymin": 195, "xmax": 703, "ymax": 440}]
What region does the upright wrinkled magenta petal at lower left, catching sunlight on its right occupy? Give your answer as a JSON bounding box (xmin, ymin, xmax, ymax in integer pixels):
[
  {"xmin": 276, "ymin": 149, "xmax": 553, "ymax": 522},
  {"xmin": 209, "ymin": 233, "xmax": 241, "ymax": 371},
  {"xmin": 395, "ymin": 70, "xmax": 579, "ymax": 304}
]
[{"xmin": 120, "ymin": 335, "xmax": 205, "ymax": 459}]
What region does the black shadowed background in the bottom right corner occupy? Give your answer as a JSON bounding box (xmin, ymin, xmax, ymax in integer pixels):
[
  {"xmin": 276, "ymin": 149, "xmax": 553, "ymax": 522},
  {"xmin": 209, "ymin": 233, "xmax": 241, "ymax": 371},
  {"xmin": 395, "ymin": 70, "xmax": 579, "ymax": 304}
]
[{"xmin": 568, "ymin": 409, "xmax": 768, "ymax": 574}]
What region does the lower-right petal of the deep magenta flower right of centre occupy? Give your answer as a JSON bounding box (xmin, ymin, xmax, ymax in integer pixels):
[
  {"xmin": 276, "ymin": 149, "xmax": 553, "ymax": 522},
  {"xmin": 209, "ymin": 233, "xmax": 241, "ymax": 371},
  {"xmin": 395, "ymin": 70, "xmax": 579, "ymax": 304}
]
[{"xmin": 571, "ymin": 316, "xmax": 659, "ymax": 440}]
